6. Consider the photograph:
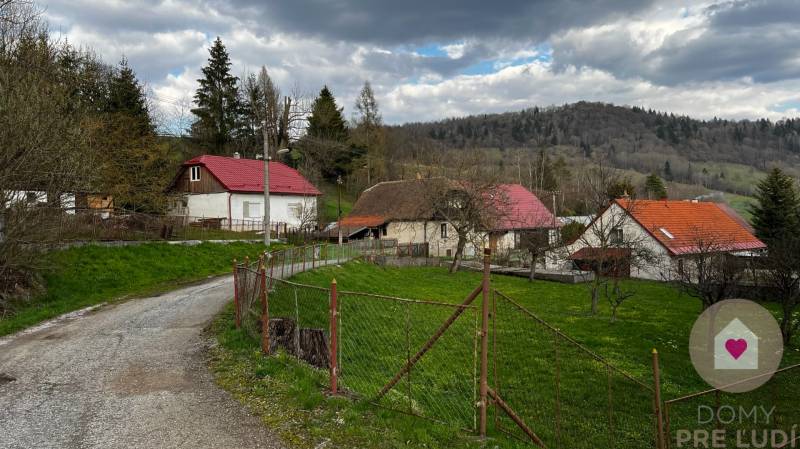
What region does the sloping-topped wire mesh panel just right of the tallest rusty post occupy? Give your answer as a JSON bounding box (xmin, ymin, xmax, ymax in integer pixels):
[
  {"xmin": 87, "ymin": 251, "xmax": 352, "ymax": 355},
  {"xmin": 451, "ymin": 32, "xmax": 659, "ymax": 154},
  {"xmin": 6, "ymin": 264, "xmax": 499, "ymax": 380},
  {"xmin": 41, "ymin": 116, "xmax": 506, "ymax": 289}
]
[{"xmin": 490, "ymin": 290, "xmax": 656, "ymax": 449}]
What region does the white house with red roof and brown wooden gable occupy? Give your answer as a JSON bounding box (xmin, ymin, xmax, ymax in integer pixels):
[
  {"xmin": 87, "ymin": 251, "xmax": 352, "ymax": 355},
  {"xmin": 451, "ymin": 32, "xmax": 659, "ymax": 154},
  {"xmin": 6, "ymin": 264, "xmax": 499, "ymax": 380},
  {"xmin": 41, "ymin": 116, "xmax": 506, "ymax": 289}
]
[{"xmin": 168, "ymin": 155, "xmax": 322, "ymax": 230}]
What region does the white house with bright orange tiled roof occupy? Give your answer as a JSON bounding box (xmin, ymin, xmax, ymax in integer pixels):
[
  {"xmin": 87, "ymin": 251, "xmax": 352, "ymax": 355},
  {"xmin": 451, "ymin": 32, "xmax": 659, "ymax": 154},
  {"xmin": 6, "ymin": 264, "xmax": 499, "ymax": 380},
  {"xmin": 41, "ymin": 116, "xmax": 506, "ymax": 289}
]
[{"xmin": 568, "ymin": 199, "xmax": 766, "ymax": 280}]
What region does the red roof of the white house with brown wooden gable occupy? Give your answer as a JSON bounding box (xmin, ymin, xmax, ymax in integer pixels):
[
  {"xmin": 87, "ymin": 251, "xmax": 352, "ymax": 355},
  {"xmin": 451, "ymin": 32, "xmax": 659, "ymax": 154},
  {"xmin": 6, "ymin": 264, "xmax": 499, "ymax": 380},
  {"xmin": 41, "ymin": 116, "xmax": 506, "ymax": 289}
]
[{"xmin": 183, "ymin": 155, "xmax": 322, "ymax": 196}]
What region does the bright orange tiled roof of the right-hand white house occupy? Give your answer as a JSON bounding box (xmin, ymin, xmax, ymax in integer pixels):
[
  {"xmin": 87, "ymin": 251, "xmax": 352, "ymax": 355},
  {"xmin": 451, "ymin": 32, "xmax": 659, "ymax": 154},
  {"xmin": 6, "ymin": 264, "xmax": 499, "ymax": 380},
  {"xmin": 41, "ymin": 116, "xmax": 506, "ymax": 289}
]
[{"xmin": 616, "ymin": 199, "xmax": 766, "ymax": 255}]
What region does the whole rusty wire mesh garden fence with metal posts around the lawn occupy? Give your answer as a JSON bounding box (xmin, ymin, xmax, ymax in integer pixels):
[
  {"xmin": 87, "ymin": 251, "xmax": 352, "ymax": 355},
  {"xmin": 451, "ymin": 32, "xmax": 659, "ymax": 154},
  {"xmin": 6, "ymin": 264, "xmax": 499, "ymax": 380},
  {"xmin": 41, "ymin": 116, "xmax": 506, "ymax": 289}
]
[{"xmin": 234, "ymin": 241, "xmax": 800, "ymax": 449}]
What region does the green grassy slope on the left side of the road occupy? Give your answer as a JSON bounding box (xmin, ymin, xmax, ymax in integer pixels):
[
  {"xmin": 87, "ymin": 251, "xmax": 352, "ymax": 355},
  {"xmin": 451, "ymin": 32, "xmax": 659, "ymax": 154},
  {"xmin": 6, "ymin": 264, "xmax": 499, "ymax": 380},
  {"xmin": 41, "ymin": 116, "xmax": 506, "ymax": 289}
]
[{"xmin": 0, "ymin": 243, "xmax": 272, "ymax": 335}]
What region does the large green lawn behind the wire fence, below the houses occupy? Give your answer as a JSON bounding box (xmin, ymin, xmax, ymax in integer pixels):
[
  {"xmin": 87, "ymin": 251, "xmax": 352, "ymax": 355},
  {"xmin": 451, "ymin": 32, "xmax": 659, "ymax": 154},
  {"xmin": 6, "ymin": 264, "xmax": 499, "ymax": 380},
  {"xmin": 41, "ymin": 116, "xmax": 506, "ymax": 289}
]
[{"xmin": 222, "ymin": 262, "xmax": 800, "ymax": 448}]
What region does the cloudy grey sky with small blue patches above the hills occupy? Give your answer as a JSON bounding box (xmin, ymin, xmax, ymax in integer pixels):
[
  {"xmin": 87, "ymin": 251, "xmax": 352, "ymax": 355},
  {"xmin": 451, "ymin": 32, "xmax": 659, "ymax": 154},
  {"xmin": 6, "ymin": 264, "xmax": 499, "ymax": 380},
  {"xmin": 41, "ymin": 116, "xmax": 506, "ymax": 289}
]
[{"xmin": 40, "ymin": 0, "xmax": 800, "ymax": 128}]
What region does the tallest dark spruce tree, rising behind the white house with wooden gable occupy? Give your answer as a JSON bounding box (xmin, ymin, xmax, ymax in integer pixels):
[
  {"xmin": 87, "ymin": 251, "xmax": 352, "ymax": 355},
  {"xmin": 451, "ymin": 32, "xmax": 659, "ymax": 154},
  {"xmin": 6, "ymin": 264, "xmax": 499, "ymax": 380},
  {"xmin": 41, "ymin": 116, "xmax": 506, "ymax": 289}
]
[{"xmin": 192, "ymin": 37, "xmax": 242, "ymax": 154}]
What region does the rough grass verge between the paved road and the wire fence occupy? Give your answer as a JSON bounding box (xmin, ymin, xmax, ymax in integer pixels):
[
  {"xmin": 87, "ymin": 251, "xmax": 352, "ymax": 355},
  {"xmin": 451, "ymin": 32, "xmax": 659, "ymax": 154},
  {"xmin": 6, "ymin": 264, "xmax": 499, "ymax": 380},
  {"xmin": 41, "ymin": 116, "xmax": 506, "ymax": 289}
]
[{"xmin": 210, "ymin": 305, "xmax": 481, "ymax": 449}]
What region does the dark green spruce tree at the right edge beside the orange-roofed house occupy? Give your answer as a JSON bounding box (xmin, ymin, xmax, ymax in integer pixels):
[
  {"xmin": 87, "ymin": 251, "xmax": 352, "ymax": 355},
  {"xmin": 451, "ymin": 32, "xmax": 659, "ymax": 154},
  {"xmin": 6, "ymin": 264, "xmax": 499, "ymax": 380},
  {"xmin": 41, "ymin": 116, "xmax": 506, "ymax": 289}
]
[{"xmin": 751, "ymin": 167, "xmax": 800, "ymax": 245}]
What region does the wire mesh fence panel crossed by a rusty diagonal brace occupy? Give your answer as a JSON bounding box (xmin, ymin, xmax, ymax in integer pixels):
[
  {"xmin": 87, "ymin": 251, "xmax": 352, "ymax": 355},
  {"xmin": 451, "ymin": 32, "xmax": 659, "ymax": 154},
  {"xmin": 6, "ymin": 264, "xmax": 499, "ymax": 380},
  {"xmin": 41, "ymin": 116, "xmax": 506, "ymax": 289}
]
[{"xmin": 339, "ymin": 292, "xmax": 478, "ymax": 429}]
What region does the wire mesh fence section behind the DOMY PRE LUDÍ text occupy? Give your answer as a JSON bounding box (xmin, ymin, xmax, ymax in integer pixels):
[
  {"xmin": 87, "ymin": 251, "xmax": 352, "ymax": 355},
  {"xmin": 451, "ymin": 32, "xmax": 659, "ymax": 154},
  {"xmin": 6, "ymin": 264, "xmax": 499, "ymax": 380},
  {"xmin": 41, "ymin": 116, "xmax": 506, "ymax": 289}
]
[{"xmin": 664, "ymin": 365, "xmax": 800, "ymax": 448}]
